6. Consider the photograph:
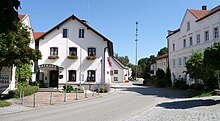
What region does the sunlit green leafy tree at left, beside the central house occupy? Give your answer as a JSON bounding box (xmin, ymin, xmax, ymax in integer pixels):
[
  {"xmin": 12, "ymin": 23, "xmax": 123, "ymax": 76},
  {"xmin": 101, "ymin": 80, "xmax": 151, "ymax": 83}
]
[{"xmin": 0, "ymin": 23, "xmax": 41, "ymax": 70}]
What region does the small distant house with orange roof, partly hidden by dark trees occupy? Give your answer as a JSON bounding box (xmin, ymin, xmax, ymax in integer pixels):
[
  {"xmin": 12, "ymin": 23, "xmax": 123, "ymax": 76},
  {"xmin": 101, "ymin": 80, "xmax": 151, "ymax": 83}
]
[{"xmin": 151, "ymin": 53, "xmax": 168, "ymax": 75}]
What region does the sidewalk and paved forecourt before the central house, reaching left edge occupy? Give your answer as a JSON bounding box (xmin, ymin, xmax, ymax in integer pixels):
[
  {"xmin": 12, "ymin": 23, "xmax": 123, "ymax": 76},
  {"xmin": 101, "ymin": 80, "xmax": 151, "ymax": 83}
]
[{"xmin": 0, "ymin": 89, "xmax": 114, "ymax": 115}]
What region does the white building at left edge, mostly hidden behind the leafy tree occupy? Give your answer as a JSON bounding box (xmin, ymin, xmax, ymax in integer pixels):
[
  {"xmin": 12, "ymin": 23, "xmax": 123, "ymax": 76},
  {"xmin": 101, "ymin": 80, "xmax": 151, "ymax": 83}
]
[{"xmin": 0, "ymin": 14, "xmax": 35, "ymax": 93}]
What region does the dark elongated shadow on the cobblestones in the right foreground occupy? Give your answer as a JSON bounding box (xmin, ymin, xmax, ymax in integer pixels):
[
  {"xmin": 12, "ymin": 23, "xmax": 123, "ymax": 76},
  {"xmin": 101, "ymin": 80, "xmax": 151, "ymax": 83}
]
[{"xmin": 157, "ymin": 99, "xmax": 220, "ymax": 109}]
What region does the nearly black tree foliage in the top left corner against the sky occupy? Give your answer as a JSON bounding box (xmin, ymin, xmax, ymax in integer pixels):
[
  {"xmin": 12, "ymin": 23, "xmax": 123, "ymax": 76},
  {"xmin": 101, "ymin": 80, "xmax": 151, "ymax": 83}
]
[{"xmin": 0, "ymin": 0, "xmax": 20, "ymax": 33}]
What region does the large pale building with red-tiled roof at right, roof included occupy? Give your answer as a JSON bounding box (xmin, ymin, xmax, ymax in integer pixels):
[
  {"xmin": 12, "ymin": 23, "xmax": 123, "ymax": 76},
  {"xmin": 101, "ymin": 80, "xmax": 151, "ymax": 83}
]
[{"xmin": 167, "ymin": 6, "xmax": 220, "ymax": 84}]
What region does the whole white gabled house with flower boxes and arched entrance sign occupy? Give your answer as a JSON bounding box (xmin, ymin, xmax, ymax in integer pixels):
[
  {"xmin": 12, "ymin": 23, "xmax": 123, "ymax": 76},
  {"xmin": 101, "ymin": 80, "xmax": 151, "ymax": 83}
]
[{"xmin": 36, "ymin": 15, "xmax": 113, "ymax": 87}]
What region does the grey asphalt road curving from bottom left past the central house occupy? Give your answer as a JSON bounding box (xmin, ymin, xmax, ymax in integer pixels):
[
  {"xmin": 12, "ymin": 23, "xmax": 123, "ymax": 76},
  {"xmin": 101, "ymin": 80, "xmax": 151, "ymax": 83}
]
[{"xmin": 0, "ymin": 84, "xmax": 187, "ymax": 121}]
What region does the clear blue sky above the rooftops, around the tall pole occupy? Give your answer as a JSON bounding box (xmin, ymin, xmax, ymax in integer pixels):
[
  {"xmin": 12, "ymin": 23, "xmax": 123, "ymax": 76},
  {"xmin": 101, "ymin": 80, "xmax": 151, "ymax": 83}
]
[{"xmin": 19, "ymin": 0, "xmax": 220, "ymax": 64}]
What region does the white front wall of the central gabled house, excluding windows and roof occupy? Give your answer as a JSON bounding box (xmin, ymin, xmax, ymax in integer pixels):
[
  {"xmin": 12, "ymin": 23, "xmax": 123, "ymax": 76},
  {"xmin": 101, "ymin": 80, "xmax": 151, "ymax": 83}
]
[{"xmin": 38, "ymin": 19, "xmax": 110, "ymax": 84}]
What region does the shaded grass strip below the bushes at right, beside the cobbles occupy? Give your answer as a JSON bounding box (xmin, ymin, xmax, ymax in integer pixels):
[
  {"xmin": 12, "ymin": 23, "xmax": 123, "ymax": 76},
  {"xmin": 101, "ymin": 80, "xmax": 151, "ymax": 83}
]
[{"xmin": 187, "ymin": 90, "xmax": 214, "ymax": 98}]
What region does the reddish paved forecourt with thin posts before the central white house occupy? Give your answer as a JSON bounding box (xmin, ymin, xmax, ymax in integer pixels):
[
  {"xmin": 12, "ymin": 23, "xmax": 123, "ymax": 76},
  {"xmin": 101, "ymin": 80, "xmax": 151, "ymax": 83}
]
[{"xmin": 14, "ymin": 90, "xmax": 106, "ymax": 107}]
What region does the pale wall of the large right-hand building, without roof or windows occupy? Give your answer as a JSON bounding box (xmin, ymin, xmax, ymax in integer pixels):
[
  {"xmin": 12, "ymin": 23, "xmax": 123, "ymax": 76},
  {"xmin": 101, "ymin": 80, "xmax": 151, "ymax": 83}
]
[{"xmin": 168, "ymin": 10, "xmax": 220, "ymax": 84}]
